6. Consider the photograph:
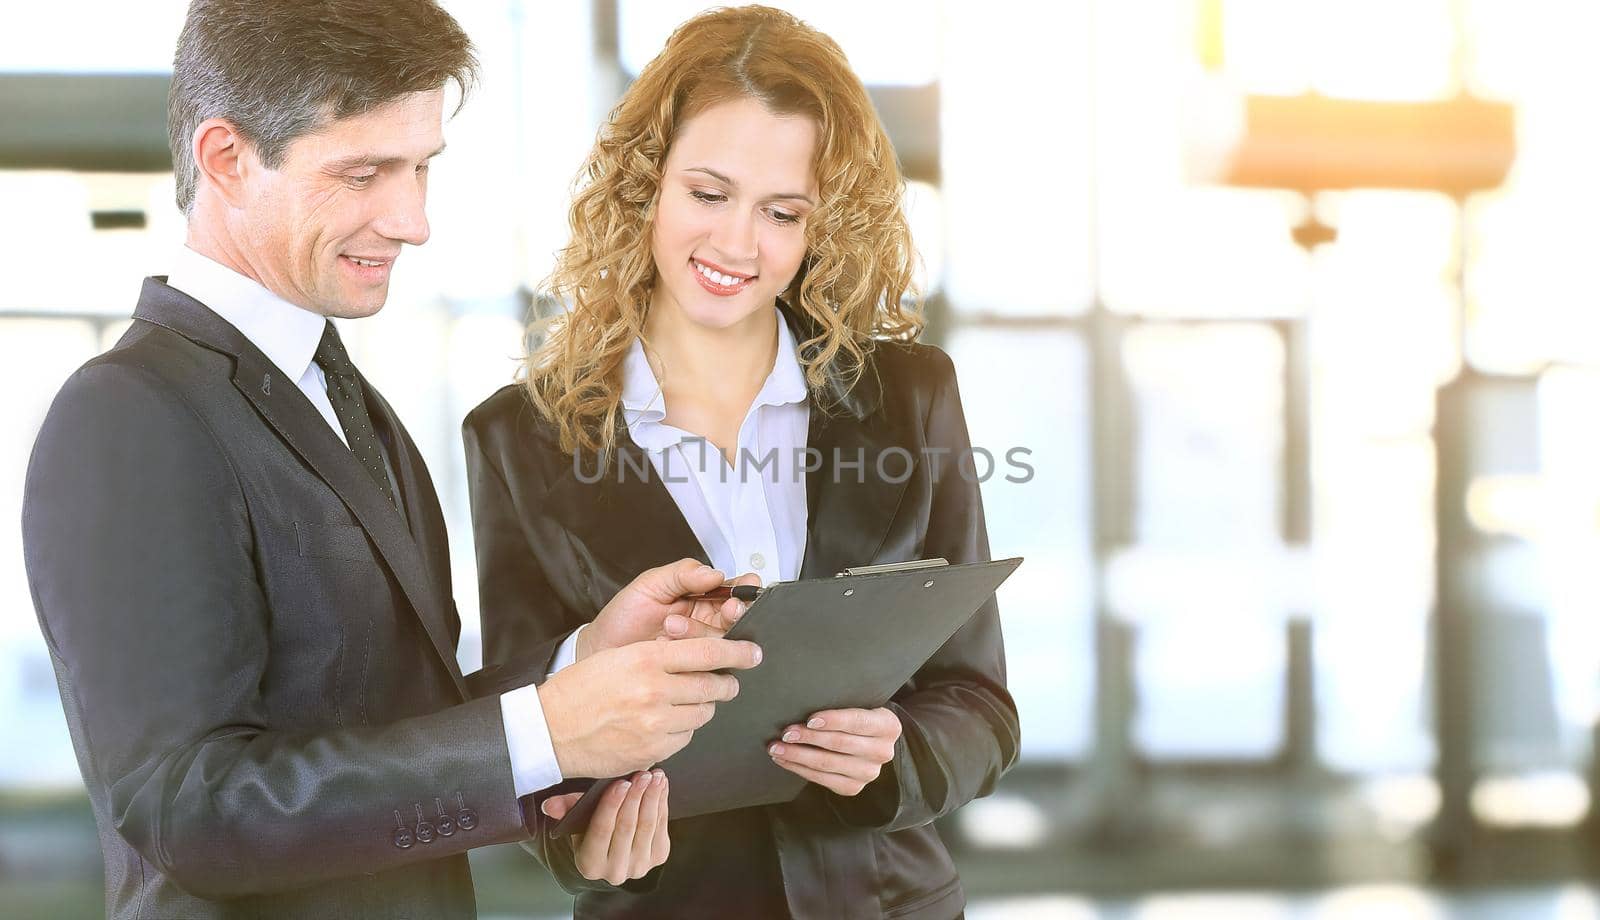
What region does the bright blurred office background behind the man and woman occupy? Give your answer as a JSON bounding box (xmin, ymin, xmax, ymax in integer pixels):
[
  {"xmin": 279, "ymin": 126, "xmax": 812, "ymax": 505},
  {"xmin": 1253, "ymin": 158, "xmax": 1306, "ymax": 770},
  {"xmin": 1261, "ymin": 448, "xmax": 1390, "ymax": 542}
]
[{"xmin": 0, "ymin": 0, "xmax": 1600, "ymax": 920}]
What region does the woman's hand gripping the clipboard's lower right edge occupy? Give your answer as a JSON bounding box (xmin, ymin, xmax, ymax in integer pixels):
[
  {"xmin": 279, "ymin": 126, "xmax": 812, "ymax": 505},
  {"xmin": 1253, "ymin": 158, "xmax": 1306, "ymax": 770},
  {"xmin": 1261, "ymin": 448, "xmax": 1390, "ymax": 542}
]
[{"xmin": 766, "ymin": 707, "xmax": 901, "ymax": 795}]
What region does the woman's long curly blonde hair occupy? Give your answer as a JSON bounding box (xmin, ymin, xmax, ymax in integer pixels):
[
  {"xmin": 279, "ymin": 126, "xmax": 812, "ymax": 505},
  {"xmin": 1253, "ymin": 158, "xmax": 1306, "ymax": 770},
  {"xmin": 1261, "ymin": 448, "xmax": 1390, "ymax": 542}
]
[{"xmin": 522, "ymin": 6, "xmax": 923, "ymax": 453}]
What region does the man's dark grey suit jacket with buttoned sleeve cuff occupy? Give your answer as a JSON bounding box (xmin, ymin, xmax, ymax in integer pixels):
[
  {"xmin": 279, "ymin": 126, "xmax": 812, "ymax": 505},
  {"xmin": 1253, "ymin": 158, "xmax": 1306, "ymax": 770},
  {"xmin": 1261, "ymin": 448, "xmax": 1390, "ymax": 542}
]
[{"xmin": 22, "ymin": 278, "xmax": 526, "ymax": 918}]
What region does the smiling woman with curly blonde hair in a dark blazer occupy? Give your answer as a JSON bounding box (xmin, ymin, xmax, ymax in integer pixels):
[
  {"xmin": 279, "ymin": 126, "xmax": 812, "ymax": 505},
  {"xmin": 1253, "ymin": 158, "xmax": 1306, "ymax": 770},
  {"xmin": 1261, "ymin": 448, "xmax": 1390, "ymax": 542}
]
[{"xmin": 464, "ymin": 6, "xmax": 1018, "ymax": 920}]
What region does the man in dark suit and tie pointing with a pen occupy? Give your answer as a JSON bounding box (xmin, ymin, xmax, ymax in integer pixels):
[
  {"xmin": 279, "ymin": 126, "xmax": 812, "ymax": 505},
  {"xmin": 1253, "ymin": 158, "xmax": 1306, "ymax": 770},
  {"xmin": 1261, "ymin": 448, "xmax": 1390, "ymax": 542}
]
[{"xmin": 22, "ymin": 0, "xmax": 760, "ymax": 918}]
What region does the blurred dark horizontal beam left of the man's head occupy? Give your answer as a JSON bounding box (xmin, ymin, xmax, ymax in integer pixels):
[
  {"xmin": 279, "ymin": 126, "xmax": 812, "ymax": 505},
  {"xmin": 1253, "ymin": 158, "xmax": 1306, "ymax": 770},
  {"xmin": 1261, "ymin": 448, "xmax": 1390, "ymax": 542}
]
[{"xmin": 0, "ymin": 74, "xmax": 173, "ymax": 173}]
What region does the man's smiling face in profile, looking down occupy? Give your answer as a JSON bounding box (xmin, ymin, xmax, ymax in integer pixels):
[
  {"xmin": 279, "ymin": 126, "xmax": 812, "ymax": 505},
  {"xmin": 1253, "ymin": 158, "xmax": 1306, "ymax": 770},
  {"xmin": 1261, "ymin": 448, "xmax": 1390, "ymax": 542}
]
[{"xmin": 237, "ymin": 90, "xmax": 445, "ymax": 318}]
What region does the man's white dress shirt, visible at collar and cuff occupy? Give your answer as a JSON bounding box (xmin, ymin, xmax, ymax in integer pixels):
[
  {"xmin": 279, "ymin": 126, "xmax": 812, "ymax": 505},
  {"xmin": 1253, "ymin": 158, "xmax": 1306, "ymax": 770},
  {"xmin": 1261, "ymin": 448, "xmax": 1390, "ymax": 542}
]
[{"xmin": 166, "ymin": 246, "xmax": 562, "ymax": 795}]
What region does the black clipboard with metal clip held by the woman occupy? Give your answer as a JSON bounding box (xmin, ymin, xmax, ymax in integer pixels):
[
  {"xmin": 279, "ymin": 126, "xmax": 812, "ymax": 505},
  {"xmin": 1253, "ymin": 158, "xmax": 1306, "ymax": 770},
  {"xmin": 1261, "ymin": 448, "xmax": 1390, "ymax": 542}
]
[{"xmin": 549, "ymin": 558, "xmax": 1022, "ymax": 837}]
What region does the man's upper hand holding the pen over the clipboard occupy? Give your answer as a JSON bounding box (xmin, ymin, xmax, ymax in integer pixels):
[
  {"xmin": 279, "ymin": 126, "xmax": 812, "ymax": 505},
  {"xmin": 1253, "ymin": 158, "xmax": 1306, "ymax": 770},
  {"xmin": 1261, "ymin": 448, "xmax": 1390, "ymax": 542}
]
[{"xmin": 576, "ymin": 558, "xmax": 760, "ymax": 661}]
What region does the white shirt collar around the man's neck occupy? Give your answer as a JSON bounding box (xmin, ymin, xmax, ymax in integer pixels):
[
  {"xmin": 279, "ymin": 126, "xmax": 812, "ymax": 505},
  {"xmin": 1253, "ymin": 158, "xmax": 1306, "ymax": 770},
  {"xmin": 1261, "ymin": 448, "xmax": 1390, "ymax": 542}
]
[{"xmin": 166, "ymin": 246, "xmax": 328, "ymax": 381}]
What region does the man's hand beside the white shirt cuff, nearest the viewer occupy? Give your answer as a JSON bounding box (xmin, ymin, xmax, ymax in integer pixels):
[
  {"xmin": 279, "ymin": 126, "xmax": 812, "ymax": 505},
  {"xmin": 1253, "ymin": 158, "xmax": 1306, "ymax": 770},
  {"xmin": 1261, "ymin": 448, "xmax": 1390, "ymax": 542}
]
[{"xmin": 539, "ymin": 638, "xmax": 762, "ymax": 779}]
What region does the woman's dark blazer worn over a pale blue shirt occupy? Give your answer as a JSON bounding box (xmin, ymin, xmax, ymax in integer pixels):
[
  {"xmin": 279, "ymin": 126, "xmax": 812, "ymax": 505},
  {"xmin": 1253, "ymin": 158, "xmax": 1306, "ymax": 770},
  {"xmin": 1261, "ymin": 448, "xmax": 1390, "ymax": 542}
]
[{"xmin": 462, "ymin": 315, "xmax": 1019, "ymax": 920}]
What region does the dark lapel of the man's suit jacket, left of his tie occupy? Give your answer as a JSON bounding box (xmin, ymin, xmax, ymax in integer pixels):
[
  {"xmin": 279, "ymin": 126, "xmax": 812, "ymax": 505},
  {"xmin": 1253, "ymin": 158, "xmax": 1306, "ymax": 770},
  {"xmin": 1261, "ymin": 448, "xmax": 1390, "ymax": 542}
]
[{"xmin": 134, "ymin": 278, "xmax": 467, "ymax": 698}]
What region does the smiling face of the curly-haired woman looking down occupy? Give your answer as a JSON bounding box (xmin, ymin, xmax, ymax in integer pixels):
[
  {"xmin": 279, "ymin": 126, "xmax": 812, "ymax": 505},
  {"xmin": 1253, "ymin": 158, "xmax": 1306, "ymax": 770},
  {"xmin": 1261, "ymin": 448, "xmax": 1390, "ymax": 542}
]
[{"xmin": 651, "ymin": 99, "xmax": 818, "ymax": 330}]
